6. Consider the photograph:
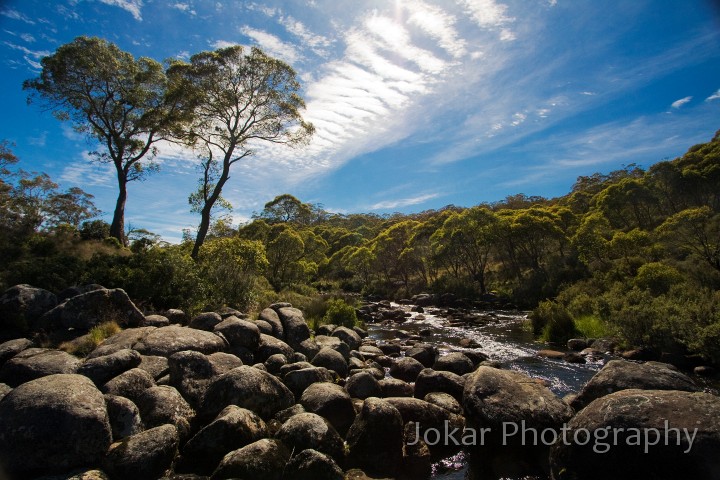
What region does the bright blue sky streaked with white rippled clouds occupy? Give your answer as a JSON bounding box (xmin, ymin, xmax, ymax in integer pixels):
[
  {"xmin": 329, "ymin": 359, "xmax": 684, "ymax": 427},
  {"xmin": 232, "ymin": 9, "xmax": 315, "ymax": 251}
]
[{"xmin": 0, "ymin": 0, "xmax": 720, "ymax": 240}]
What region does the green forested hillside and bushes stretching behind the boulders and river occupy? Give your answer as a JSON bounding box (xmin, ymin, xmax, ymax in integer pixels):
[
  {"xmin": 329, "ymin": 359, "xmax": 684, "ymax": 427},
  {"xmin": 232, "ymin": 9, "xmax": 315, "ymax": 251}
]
[{"xmin": 0, "ymin": 132, "xmax": 720, "ymax": 363}]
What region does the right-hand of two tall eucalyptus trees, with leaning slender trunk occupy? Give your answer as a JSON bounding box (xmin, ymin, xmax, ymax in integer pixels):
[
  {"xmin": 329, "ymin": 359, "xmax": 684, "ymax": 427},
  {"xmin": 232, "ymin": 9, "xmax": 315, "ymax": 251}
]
[{"xmin": 168, "ymin": 46, "xmax": 314, "ymax": 258}]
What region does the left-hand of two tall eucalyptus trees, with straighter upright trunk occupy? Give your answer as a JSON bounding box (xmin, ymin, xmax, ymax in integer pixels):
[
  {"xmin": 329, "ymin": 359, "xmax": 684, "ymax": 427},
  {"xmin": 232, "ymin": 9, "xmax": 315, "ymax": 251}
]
[{"xmin": 23, "ymin": 37, "xmax": 188, "ymax": 245}]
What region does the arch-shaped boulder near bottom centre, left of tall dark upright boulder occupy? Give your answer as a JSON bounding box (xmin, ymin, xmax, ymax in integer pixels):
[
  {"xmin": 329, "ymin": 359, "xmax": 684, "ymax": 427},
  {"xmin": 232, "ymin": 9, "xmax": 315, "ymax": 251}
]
[{"xmin": 275, "ymin": 413, "xmax": 345, "ymax": 463}]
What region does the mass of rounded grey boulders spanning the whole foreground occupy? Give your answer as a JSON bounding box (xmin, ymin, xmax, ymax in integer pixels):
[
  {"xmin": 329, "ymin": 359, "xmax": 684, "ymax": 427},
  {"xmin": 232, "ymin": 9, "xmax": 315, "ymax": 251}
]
[{"xmin": 0, "ymin": 286, "xmax": 720, "ymax": 480}]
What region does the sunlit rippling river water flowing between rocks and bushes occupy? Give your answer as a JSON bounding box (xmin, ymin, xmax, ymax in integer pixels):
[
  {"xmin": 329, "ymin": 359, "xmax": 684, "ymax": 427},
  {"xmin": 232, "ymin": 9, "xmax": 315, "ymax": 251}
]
[{"xmin": 368, "ymin": 305, "xmax": 604, "ymax": 480}]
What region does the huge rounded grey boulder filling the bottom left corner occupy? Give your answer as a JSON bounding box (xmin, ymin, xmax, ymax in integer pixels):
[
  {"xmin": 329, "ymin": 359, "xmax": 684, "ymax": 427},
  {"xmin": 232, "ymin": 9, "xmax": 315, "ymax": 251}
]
[{"xmin": 0, "ymin": 374, "xmax": 112, "ymax": 477}]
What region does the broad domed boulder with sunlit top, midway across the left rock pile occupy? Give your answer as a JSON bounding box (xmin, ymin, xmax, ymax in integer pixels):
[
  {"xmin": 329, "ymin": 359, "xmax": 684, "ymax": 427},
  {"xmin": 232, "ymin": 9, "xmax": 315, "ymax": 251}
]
[{"xmin": 200, "ymin": 366, "xmax": 295, "ymax": 419}]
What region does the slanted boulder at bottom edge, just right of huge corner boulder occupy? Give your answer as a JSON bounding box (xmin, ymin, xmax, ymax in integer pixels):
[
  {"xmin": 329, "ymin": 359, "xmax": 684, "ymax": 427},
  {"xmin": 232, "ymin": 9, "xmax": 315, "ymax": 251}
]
[{"xmin": 103, "ymin": 425, "xmax": 179, "ymax": 480}]
